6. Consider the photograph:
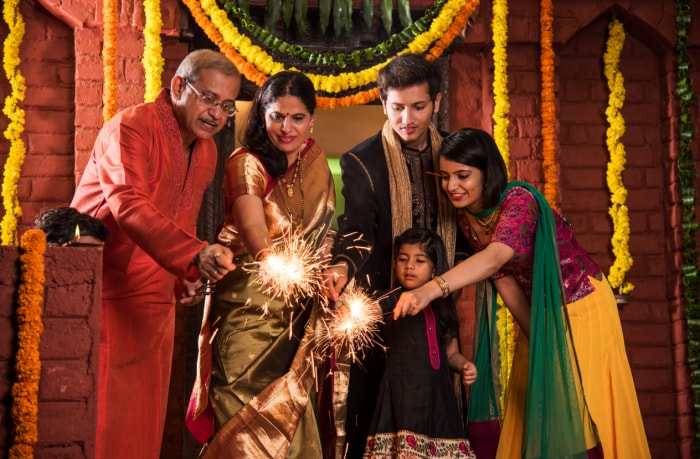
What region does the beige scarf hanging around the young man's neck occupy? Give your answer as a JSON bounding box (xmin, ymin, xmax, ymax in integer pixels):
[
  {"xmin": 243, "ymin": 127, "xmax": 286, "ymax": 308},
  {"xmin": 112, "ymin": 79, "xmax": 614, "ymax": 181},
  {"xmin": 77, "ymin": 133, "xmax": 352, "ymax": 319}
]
[{"xmin": 382, "ymin": 121, "xmax": 457, "ymax": 285}]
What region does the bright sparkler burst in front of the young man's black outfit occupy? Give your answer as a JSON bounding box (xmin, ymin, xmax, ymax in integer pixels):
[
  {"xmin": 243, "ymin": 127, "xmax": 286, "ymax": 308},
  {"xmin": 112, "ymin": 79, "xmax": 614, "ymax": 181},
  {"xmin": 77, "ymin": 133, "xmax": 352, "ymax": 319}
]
[{"xmin": 327, "ymin": 285, "xmax": 383, "ymax": 361}]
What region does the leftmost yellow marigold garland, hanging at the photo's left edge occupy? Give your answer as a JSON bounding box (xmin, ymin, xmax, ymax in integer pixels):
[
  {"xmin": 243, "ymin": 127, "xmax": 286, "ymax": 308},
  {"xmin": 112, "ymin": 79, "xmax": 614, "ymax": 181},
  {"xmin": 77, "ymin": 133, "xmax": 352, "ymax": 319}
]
[{"xmin": 0, "ymin": 0, "xmax": 27, "ymax": 245}]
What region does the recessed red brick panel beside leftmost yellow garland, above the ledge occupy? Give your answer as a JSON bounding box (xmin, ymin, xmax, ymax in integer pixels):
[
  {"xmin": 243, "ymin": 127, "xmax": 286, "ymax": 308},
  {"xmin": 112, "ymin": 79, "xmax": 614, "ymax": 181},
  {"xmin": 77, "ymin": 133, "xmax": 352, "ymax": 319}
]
[{"xmin": 0, "ymin": 3, "xmax": 75, "ymax": 229}]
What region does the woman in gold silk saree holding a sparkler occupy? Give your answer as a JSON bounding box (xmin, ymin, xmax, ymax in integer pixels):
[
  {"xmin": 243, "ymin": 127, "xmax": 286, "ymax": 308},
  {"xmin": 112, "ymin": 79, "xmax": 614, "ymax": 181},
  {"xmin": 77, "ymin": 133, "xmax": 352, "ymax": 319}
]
[{"xmin": 190, "ymin": 71, "xmax": 335, "ymax": 458}]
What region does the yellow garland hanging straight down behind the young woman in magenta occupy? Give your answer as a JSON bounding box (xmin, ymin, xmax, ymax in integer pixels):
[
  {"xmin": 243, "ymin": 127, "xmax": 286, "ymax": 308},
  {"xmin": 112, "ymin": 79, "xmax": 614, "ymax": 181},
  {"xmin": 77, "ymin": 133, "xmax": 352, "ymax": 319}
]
[{"xmin": 491, "ymin": 0, "xmax": 515, "ymax": 406}]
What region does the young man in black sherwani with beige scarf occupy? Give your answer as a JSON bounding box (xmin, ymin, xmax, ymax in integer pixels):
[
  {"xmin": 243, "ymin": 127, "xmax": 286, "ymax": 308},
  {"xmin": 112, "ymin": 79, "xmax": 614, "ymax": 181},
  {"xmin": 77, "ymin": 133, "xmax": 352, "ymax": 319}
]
[{"xmin": 326, "ymin": 54, "xmax": 456, "ymax": 458}]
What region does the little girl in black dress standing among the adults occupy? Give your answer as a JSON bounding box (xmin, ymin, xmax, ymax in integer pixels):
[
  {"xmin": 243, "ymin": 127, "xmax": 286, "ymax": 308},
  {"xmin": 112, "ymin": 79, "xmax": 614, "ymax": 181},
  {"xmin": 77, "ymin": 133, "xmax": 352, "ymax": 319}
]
[{"xmin": 364, "ymin": 228, "xmax": 476, "ymax": 459}]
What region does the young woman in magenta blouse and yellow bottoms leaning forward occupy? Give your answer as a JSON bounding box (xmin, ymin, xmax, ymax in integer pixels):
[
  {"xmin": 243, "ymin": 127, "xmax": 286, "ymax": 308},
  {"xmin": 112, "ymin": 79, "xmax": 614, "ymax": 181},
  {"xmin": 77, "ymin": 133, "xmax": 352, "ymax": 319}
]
[{"xmin": 394, "ymin": 129, "xmax": 650, "ymax": 458}]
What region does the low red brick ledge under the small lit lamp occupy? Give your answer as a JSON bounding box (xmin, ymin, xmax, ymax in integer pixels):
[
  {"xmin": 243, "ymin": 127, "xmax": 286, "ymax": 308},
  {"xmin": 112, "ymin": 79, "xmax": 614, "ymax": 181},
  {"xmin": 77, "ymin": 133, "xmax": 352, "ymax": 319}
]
[{"xmin": 0, "ymin": 247, "xmax": 102, "ymax": 459}]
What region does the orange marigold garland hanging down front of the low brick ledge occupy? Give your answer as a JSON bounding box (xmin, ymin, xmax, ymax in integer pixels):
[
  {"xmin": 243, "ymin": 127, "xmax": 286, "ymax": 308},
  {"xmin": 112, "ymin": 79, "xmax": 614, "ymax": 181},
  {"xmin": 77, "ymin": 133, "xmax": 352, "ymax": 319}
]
[{"xmin": 9, "ymin": 230, "xmax": 46, "ymax": 459}]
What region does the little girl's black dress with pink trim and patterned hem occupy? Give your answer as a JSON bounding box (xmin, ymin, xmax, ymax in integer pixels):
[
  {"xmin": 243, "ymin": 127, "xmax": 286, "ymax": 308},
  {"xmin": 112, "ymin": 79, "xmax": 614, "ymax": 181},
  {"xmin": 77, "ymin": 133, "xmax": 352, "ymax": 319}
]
[{"xmin": 364, "ymin": 291, "xmax": 476, "ymax": 459}]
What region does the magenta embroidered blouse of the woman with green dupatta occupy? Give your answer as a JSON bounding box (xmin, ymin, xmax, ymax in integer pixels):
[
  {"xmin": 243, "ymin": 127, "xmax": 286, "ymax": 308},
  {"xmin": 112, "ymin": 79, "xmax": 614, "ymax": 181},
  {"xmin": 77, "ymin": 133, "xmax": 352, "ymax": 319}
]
[{"xmin": 458, "ymin": 186, "xmax": 603, "ymax": 304}]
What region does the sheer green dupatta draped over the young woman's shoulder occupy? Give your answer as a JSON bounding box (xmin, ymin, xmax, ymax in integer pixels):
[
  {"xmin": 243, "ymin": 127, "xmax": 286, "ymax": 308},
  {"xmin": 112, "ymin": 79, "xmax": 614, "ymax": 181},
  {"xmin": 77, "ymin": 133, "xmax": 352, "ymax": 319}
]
[{"xmin": 468, "ymin": 182, "xmax": 594, "ymax": 459}]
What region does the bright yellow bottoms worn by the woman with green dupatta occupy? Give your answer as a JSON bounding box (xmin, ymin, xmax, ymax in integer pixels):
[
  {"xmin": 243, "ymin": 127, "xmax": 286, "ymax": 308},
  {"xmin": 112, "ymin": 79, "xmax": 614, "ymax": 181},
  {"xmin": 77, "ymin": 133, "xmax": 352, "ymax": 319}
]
[{"xmin": 496, "ymin": 278, "xmax": 651, "ymax": 459}]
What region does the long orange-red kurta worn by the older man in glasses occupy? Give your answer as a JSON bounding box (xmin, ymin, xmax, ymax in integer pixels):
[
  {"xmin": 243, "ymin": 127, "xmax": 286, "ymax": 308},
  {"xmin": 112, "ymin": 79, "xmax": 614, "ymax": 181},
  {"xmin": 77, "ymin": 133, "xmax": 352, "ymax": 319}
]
[{"xmin": 71, "ymin": 90, "xmax": 217, "ymax": 459}]
